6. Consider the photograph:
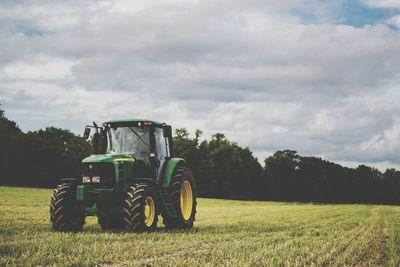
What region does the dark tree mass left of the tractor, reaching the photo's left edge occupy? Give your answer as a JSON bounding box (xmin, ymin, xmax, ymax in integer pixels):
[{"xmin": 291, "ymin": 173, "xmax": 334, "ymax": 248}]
[{"xmin": 0, "ymin": 110, "xmax": 91, "ymax": 187}]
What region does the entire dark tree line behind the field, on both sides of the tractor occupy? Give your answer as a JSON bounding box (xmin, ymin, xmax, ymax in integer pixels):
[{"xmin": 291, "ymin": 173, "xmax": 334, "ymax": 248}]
[{"xmin": 0, "ymin": 107, "xmax": 400, "ymax": 204}]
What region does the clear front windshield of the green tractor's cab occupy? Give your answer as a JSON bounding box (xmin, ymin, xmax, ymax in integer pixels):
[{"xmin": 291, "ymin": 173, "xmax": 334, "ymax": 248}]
[{"xmin": 107, "ymin": 126, "xmax": 150, "ymax": 159}]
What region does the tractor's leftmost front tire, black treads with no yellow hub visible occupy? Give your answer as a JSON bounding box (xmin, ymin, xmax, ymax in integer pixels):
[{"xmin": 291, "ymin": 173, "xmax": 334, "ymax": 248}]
[{"xmin": 50, "ymin": 183, "xmax": 85, "ymax": 231}]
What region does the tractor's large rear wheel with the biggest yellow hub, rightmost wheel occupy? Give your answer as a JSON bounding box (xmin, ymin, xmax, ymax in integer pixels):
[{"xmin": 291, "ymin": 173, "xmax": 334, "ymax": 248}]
[{"xmin": 161, "ymin": 167, "xmax": 197, "ymax": 229}]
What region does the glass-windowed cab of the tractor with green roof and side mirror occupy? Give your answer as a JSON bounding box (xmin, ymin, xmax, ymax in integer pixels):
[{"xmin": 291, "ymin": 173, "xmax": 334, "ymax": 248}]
[{"xmin": 84, "ymin": 119, "xmax": 174, "ymax": 182}]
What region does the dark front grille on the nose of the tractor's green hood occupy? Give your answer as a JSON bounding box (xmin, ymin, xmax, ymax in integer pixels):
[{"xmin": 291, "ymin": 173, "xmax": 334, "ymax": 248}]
[{"xmin": 82, "ymin": 162, "xmax": 115, "ymax": 185}]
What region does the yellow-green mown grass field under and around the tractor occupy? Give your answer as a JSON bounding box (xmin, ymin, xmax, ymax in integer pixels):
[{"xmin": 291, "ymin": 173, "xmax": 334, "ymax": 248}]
[{"xmin": 0, "ymin": 187, "xmax": 400, "ymax": 266}]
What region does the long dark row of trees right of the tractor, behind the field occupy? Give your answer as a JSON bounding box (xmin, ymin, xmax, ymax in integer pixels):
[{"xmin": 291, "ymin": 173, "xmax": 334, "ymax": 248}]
[{"xmin": 174, "ymin": 129, "xmax": 400, "ymax": 204}]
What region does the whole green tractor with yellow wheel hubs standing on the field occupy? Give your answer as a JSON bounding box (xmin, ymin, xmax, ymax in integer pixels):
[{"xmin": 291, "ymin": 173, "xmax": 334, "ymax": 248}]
[{"xmin": 50, "ymin": 119, "xmax": 197, "ymax": 231}]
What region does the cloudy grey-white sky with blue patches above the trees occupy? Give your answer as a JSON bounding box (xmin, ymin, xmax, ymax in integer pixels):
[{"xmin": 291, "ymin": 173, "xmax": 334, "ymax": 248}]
[{"xmin": 0, "ymin": 0, "xmax": 400, "ymax": 168}]
